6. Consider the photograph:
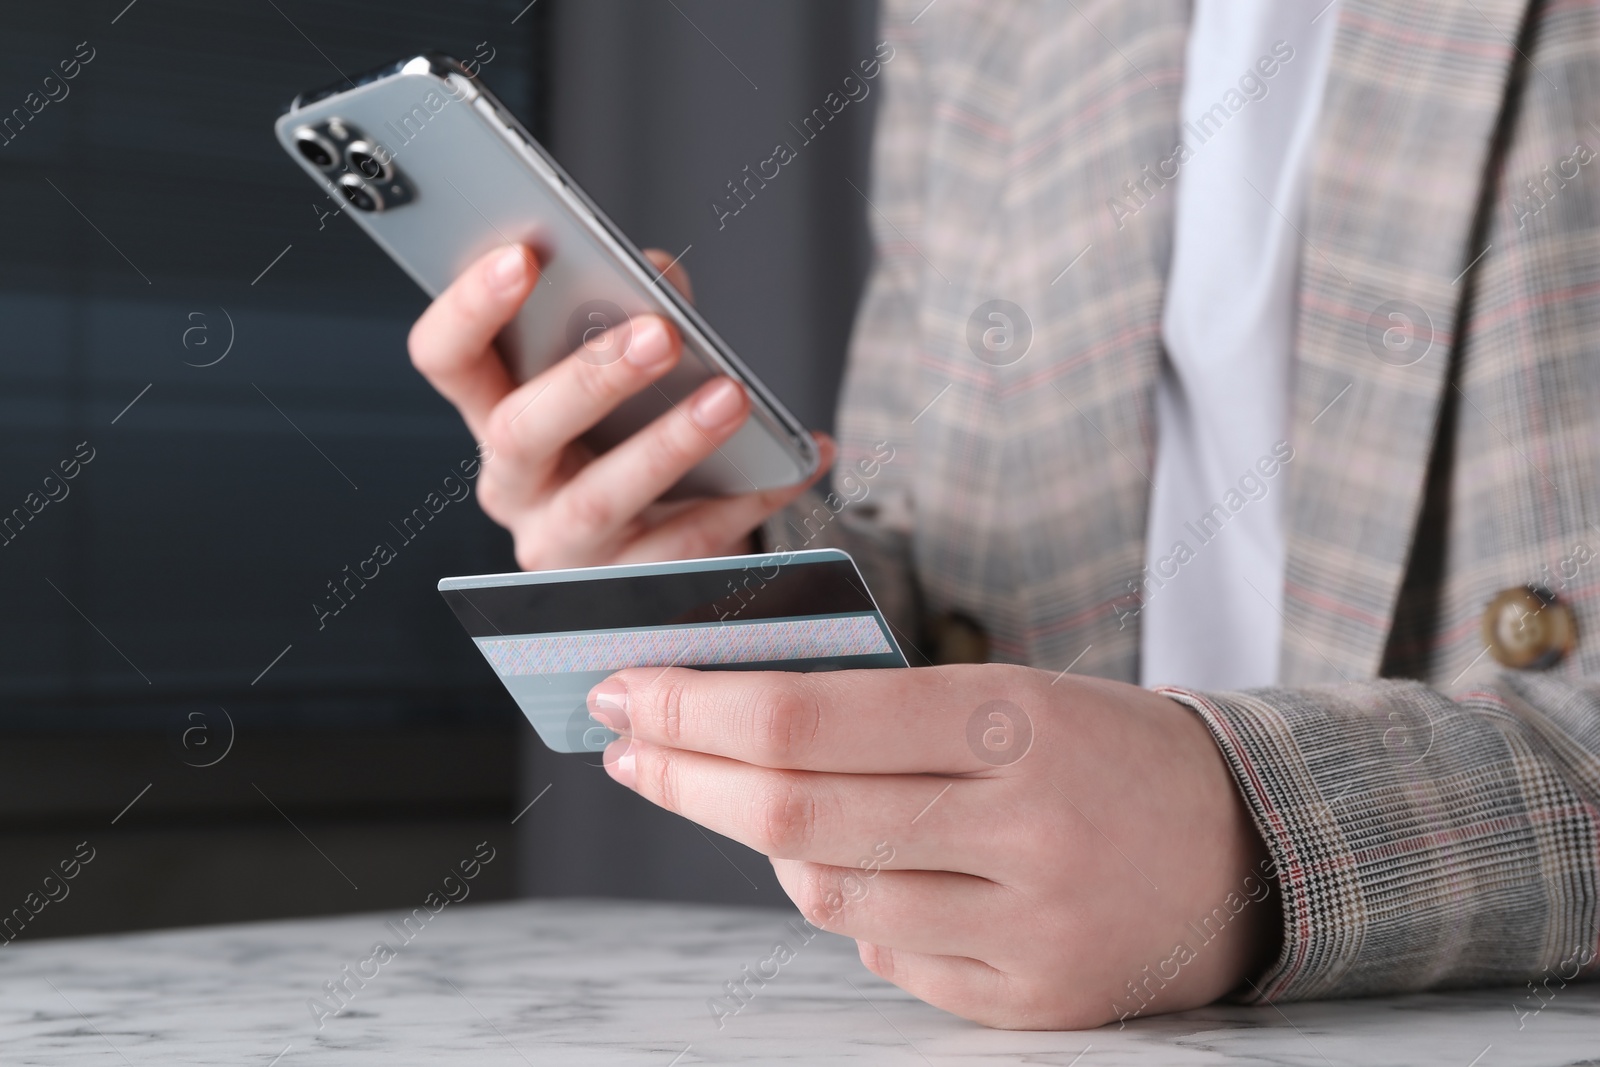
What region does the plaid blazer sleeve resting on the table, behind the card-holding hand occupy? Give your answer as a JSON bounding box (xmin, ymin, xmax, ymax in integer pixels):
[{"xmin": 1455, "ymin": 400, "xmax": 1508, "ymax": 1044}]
[{"xmin": 1163, "ymin": 672, "xmax": 1600, "ymax": 1000}]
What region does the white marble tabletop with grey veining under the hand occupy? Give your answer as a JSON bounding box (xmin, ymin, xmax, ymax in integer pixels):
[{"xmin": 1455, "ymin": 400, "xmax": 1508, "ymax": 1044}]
[{"xmin": 0, "ymin": 902, "xmax": 1600, "ymax": 1067}]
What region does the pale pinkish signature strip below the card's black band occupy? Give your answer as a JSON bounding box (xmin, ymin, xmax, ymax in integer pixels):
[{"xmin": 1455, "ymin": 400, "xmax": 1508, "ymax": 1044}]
[{"xmin": 478, "ymin": 614, "xmax": 893, "ymax": 677}]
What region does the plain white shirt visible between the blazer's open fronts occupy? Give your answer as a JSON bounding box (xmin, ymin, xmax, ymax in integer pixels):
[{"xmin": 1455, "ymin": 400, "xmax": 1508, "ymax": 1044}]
[{"xmin": 1139, "ymin": 0, "xmax": 1338, "ymax": 689}]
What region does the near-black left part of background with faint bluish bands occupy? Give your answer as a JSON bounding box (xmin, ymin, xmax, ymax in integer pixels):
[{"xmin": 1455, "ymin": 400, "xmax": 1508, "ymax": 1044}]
[{"xmin": 0, "ymin": 0, "xmax": 538, "ymax": 937}]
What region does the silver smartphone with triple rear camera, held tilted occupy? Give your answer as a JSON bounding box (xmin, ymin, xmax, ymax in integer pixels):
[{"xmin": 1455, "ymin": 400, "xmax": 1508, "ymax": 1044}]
[{"xmin": 277, "ymin": 54, "xmax": 819, "ymax": 498}]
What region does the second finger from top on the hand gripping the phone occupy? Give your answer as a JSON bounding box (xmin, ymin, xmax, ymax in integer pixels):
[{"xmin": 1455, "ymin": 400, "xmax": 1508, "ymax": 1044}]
[{"xmin": 485, "ymin": 315, "xmax": 680, "ymax": 491}]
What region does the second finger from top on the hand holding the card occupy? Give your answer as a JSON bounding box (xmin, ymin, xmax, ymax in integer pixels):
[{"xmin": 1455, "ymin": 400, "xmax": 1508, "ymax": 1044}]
[{"xmin": 606, "ymin": 741, "xmax": 1016, "ymax": 877}]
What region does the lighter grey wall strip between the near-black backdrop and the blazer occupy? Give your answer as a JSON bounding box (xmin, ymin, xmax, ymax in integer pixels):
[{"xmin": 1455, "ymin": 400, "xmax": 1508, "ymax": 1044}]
[{"xmin": 518, "ymin": 0, "xmax": 877, "ymax": 904}]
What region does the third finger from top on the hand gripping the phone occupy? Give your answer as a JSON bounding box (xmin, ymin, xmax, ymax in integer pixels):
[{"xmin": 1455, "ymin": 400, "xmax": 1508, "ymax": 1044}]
[{"xmin": 550, "ymin": 378, "xmax": 750, "ymax": 544}]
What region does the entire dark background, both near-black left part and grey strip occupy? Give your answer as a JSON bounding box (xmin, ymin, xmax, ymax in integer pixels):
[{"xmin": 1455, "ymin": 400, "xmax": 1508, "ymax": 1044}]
[{"xmin": 0, "ymin": 0, "xmax": 877, "ymax": 937}]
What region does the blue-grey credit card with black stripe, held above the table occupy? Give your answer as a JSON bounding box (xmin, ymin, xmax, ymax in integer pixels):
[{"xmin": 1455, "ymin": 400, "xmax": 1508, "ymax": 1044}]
[{"xmin": 438, "ymin": 549, "xmax": 907, "ymax": 752}]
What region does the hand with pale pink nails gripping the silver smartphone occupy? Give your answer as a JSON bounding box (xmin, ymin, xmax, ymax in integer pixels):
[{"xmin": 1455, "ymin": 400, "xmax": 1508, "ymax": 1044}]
[{"xmin": 410, "ymin": 246, "xmax": 834, "ymax": 571}]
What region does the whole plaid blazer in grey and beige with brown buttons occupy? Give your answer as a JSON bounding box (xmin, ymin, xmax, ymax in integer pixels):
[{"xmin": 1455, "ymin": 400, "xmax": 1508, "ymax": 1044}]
[{"xmin": 766, "ymin": 0, "xmax": 1600, "ymax": 998}]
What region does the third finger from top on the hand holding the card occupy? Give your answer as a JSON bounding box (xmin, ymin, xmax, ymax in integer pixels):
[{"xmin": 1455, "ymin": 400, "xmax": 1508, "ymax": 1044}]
[{"xmin": 773, "ymin": 859, "xmax": 998, "ymax": 958}]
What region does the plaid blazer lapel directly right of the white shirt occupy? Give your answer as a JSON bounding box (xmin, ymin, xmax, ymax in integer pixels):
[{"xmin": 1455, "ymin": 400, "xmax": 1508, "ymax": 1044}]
[{"xmin": 1280, "ymin": 0, "xmax": 1538, "ymax": 685}]
